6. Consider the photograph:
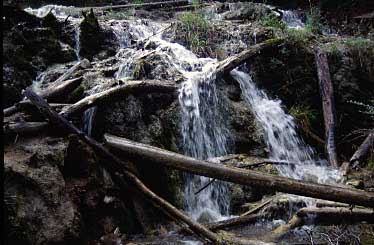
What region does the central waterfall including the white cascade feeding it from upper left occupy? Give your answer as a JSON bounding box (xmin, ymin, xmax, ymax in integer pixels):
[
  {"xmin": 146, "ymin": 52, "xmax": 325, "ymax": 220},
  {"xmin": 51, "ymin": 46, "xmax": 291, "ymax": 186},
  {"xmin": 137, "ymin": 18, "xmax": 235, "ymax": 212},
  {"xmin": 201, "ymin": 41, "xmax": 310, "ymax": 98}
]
[{"xmin": 112, "ymin": 21, "xmax": 229, "ymax": 221}]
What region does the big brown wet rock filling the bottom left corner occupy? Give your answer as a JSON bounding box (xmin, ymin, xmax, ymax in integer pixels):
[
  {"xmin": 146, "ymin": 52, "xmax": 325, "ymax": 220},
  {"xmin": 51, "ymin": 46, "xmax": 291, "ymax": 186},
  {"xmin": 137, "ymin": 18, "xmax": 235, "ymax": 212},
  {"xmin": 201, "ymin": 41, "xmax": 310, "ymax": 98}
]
[{"xmin": 4, "ymin": 138, "xmax": 82, "ymax": 244}]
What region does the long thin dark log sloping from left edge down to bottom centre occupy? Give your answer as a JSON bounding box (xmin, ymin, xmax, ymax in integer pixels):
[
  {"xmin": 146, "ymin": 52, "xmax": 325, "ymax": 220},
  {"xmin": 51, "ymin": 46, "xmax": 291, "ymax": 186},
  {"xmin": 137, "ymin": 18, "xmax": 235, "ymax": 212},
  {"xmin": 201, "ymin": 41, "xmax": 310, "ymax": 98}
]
[{"xmin": 25, "ymin": 88, "xmax": 220, "ymax": 243}]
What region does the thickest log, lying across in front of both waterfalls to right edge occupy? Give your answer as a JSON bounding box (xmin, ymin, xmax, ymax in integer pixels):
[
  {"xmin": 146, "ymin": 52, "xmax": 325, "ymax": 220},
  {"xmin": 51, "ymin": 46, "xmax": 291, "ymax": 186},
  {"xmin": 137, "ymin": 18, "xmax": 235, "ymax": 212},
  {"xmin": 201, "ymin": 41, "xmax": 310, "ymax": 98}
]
[{"xmin": 104, "ymin": 134, "xmax": 374, "ymax": 207}]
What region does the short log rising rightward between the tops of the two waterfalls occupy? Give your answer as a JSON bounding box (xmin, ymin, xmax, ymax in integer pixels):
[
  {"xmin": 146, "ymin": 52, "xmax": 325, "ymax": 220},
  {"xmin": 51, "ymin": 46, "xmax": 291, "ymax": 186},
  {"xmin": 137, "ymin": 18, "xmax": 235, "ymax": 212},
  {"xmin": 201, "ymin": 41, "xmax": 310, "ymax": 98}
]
[{"xmin": 215, "ymin": 38, "xmax": 283, "ymax": 77}]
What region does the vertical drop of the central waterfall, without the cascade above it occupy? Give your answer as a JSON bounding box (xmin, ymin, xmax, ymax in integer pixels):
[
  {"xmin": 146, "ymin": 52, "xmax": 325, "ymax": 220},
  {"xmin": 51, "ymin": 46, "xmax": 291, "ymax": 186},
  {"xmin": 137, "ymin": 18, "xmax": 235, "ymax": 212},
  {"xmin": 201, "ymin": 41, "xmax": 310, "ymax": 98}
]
[{"xmin": 179, "ymin": 66, "xmax": 229, "ymax": 221}]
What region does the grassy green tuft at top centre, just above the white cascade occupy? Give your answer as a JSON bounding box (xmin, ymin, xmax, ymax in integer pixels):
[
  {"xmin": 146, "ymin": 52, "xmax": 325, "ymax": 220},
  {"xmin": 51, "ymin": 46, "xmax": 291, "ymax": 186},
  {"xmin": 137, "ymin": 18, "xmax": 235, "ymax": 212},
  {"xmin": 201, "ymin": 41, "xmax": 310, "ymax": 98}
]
[{"xmin": 178, "ymin": 12, "xmax": 210, "ymax": 51}]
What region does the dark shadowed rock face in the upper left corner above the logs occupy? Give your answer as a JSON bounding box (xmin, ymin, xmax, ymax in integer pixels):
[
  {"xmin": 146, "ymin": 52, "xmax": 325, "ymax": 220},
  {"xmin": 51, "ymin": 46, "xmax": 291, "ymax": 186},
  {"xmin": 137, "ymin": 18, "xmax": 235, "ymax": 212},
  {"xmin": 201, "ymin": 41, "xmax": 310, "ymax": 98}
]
[{"xmin": 3, "ymin": 7, "xmax": 75, "ymax": 107}]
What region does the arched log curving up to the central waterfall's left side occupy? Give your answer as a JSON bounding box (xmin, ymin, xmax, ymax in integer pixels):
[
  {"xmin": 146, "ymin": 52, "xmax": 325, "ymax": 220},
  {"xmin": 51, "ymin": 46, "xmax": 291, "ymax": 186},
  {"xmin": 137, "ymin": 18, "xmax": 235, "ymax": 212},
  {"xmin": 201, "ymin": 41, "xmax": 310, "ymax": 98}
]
[{"xmin": 61, "ymin": 80, "xmax": 177, "ymax": 117}]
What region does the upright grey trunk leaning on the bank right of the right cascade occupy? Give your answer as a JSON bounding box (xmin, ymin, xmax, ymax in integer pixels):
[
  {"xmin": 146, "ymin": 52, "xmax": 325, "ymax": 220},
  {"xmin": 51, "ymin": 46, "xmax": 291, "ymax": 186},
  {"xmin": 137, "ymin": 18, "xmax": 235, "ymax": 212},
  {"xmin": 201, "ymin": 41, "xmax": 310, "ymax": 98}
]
[{"xmin": 314, "ymin": 49, "xmax": 338, "ymax": 167}]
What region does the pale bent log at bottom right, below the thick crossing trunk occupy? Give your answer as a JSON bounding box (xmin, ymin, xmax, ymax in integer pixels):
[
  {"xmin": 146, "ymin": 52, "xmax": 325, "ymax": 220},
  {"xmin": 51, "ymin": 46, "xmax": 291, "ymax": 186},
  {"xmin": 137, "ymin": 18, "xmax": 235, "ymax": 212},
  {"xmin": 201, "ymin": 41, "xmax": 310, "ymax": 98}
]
[{"xmin": 266, "ymin": 207, "xmax": 374, "ymax": 241}]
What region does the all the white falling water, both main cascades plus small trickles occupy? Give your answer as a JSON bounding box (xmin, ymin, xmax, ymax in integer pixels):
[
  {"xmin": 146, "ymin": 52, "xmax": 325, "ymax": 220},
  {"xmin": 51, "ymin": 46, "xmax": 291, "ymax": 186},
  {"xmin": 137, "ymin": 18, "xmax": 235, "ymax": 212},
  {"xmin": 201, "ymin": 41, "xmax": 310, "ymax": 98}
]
[{"xmin": 24, "ymin": 3, "xmax": 340, "ymax": 243}]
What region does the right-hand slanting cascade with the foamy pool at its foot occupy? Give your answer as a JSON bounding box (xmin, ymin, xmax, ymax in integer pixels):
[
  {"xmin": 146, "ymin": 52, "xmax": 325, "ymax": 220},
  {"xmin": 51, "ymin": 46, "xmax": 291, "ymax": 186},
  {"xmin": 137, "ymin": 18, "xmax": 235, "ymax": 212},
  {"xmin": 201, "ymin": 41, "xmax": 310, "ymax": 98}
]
[{"xmin": 231, "ymin": 70, "xmax": 340, "ymax": 184}]
